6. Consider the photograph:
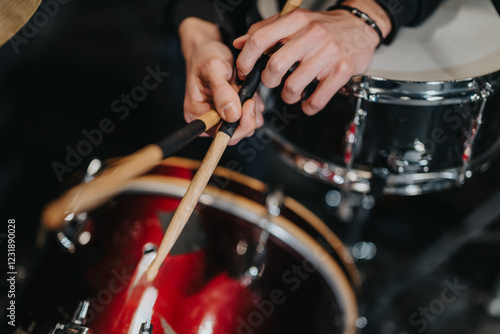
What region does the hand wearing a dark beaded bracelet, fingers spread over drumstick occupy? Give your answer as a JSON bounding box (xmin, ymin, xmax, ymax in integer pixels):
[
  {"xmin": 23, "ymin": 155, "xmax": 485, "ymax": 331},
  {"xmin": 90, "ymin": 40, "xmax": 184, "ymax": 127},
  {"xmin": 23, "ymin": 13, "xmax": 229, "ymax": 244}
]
[{"xmin": 233, "ymin": 0, "xmax": 391, "ymax": 115}]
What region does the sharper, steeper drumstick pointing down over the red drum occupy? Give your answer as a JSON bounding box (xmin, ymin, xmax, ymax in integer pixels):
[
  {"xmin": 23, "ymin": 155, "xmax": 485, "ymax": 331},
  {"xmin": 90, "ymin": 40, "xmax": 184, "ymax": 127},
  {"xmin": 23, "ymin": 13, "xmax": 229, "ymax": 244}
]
[{"xmin": 146, "ymin": 0, "xmax": 302, "ymax": 282}]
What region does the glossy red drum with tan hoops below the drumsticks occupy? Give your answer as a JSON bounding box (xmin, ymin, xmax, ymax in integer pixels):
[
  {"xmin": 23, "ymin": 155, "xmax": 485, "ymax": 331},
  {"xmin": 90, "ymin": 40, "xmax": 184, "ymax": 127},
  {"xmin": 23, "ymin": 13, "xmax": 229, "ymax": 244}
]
[{"xmin": 54, "ymin": 158, "xmax": 360, "ymax": 334}]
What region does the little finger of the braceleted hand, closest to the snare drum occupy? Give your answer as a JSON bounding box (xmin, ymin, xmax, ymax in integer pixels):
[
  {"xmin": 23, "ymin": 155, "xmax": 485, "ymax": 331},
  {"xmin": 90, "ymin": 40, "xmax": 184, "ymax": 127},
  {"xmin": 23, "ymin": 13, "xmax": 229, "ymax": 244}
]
[{"xmin": 302, "ymin": 64, "xmax": 352, "ymax": 115}]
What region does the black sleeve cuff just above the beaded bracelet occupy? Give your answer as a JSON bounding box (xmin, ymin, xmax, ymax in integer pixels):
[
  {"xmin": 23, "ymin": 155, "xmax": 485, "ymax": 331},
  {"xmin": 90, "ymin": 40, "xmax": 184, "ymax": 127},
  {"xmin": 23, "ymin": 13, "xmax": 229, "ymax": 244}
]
[{"xmin": 376, "ymin": 0, "xmax": 442, "ymax": 44}]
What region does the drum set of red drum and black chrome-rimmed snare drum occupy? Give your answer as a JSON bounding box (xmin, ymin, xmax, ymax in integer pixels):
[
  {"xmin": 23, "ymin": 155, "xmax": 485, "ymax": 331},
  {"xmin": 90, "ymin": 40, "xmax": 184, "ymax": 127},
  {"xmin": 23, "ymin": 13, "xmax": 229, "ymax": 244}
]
[{"xmin": 9, "ymin": 0, "xmax": 500, "ymax": 334}]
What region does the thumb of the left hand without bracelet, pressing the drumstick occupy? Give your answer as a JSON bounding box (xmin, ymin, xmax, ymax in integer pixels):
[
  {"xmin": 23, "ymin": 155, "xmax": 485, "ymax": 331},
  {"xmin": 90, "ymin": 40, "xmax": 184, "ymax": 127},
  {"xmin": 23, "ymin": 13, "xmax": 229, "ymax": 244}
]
[{"xmin": 210, "ymin": 79, "xmax": 241, "ymax": 123}]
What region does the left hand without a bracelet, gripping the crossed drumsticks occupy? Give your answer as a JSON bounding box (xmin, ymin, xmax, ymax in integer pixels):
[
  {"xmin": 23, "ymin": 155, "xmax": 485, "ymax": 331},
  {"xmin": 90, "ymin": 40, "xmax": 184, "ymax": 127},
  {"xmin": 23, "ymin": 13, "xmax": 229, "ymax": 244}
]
[{"xmin": 179, "ymin": 17, "xmax": 264, "ymax": 145}]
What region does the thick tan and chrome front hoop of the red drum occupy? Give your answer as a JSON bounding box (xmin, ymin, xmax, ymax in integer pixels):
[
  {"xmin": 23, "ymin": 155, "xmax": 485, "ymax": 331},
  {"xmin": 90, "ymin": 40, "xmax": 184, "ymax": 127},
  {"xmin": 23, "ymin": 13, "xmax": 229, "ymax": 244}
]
[{"xmin": 120, "ymin": 175, "xmax": 358, "ymax": 334}]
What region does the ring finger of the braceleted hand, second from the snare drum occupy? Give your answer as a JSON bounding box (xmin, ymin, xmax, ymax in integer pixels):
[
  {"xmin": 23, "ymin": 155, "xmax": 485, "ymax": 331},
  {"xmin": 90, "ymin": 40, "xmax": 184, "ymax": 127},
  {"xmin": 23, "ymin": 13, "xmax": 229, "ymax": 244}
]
[{"xmin": 281, "ymin": 52, "xmax": 331, "ymax": 104}]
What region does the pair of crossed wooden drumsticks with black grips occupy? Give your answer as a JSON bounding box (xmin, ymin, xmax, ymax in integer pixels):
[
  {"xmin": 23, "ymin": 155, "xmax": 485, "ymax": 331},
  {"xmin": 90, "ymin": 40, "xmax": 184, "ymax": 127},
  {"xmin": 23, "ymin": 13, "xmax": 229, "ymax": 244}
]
[{"xmin": 42, "ymin": 0, "xmax": 302, "ymax": 282}]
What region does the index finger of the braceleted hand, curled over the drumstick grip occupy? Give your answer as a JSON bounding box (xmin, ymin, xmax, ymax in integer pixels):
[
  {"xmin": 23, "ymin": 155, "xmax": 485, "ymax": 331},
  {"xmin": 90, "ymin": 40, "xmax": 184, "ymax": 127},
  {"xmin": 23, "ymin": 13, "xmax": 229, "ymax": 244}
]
[{"xmin": 236, "ymin": 10, "xmax": 308, "ymax": 79}]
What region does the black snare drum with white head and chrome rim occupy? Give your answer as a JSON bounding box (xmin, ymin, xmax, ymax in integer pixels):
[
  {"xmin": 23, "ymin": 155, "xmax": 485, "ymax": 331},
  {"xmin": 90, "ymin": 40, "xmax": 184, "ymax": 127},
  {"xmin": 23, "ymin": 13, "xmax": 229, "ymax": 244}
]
[{"xmin": 267, "ymin": 0, "xmax": 500, "ymax": 195}]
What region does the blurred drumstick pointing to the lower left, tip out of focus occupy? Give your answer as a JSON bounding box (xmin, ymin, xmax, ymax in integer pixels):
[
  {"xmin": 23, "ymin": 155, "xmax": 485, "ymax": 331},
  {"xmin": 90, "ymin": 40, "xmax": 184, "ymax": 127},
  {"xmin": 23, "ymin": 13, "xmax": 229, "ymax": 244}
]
[{"xmin": 42, "ymin": 110, "xmax": 221, "ymax": 230}]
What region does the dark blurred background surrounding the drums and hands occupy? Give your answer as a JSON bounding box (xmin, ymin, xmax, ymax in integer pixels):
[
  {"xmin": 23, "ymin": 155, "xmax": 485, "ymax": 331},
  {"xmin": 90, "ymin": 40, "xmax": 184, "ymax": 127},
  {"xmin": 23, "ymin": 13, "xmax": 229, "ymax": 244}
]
[{"xmin": 0, "ymin": 0, "xmax": 500, "ymax": 334}]
